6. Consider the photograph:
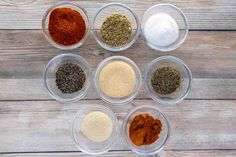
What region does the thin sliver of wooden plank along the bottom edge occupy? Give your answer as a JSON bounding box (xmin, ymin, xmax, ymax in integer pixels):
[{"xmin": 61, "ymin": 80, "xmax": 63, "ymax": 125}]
[{"xmin": 0, "ymin": 150, "xmax": 236, "ymax": 157}]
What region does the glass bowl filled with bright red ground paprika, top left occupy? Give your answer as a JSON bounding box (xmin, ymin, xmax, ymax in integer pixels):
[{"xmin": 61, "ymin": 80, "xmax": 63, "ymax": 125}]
[{"xmin": 42, "ymin": 2, "xmax": 89, "ymax": 49}]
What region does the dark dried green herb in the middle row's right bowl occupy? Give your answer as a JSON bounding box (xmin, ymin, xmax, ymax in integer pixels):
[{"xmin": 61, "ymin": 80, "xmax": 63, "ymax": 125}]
[{"xmin": 151, "ymin": 67, "xmax": 182, "ymax": 95}]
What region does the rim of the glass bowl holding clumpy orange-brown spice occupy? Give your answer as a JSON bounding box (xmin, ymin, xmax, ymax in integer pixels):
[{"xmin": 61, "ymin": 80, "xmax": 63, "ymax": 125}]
[{"xmin": 121, "ymin": 105, "xmax": 171, "ymax": 155}]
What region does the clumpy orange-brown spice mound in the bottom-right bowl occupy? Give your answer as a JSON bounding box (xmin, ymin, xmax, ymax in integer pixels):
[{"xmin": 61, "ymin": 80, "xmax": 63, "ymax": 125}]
[{"xmin": 129, "ymin": 113, "xmax": 162, "ymax": 146}]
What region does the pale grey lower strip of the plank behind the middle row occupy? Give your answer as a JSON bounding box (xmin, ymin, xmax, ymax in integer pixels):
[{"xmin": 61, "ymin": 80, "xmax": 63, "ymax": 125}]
[{"xmin": 0, "ymin": 78, "xmax": 236, "ymax": 101}]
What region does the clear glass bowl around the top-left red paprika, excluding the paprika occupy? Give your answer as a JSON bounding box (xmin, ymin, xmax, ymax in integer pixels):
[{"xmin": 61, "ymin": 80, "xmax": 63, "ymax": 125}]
[{"xmin": 42, "ymin": 2, "xmax": 89, "ymax": 50}]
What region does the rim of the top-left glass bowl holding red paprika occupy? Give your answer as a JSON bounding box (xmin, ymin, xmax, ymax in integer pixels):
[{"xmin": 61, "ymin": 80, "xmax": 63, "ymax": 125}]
[{"xmin": 41, "ymin": 1, "xmax": 90, "ymax": 50}]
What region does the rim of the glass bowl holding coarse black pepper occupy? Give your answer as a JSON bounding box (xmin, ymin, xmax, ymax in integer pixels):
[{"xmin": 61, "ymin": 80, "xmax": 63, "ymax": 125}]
[{"xmin": 43, "ymin": 53, "xmax": 91, "ymax": 103}]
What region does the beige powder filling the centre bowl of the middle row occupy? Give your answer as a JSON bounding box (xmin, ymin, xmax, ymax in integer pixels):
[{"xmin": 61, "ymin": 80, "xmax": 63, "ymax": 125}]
[{"xmin": 99, "ymin": 61, "xmax": 136, "ymax": 98}]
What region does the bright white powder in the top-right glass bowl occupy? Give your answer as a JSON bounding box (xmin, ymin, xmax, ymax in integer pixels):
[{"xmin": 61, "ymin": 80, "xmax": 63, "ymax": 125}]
[{"xmin": 144, "ymin": 13, "xmax": 179, "ymax": 47}]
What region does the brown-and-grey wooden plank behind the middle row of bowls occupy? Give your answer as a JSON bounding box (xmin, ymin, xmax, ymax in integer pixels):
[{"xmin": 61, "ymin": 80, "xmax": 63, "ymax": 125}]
[{"xmin": 0, "ymin": 30, "xmax": 236, "ymax": 100}]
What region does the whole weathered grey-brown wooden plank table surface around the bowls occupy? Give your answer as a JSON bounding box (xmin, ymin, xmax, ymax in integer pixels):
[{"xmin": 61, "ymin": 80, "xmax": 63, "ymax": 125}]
[{"xmin": 0, "ymin": 0, "xmax": 236, "ymax": 157}]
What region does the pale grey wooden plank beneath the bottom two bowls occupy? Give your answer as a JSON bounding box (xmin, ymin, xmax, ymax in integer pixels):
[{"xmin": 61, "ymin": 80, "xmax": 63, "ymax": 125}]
[{"xmin": 0, "ymin": 100, "xmax": 236, "ymax": 153}]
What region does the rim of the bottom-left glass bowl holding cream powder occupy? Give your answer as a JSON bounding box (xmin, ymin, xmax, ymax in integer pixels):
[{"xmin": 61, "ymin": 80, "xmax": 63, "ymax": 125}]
[{"xmin": 71, "ymin": 104, "xmax": 119, "ymax": 155}]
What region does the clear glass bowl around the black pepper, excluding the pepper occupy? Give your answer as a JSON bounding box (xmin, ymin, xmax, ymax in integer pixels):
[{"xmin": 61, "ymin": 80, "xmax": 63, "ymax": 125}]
[{"xmin": 43, "ymin": 53, "xmax": 91, "ymax": 103}]
